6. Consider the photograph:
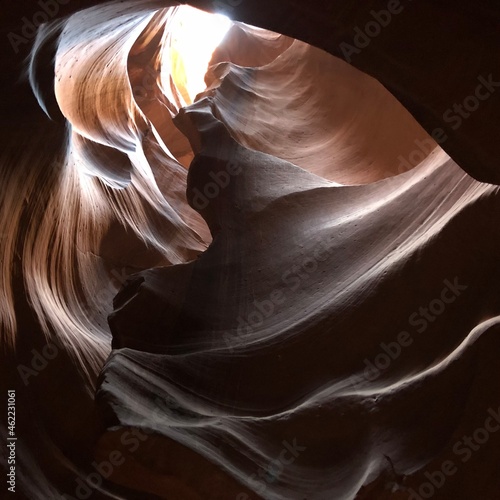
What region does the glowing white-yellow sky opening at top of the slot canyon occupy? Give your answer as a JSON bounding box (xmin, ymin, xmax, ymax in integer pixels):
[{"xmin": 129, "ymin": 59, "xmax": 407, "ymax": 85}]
[{"xmin": 165, "ymin": 6, "xmax": 233, "ymax": 104}]
